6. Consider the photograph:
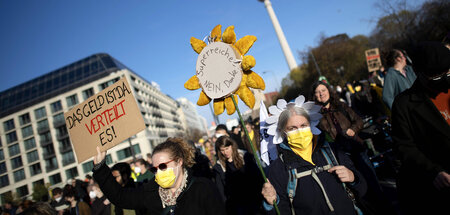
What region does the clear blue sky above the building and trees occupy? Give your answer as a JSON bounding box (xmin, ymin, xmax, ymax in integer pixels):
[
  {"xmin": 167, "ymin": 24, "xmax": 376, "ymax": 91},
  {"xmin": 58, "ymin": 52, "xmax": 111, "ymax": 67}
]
[{"xmin": 0, "ymin": 0, "xmax": 423, "ymax": 126}]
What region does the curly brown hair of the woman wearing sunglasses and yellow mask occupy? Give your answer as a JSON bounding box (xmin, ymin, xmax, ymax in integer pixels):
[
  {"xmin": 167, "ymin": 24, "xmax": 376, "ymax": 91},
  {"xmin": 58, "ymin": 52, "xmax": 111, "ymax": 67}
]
[{"xmin": 152, "ymin": 137, "xmax": 195, "ymax": 168}]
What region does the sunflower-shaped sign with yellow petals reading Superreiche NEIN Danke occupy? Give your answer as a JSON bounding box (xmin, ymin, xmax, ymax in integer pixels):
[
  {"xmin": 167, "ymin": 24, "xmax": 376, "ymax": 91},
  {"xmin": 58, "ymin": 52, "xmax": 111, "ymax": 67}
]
[{"xmin": 184, "ymin": 25, "xmax": 265, "ymax": 115}]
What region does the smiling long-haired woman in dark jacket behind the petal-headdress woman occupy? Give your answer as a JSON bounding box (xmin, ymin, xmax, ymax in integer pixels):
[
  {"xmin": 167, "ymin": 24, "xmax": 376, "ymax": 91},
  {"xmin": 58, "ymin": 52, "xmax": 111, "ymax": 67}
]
[{"xmin": 312, "ymin": 82, "xmax": 393, "ymax": 213}]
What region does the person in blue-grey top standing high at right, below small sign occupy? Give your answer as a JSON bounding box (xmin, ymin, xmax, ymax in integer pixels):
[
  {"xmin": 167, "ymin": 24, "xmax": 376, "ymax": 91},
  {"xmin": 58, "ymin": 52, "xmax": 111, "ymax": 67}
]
[{"xmin": 383, "ymin": 49, "xmax": 416, "ymax": 109}]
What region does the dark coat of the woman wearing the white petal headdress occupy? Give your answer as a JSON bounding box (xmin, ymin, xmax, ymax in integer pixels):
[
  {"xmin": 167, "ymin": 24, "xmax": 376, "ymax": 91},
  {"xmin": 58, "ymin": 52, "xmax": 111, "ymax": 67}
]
[{"xmin": 268, "ymin": 140, "xmax": 367, "ymax": 215}]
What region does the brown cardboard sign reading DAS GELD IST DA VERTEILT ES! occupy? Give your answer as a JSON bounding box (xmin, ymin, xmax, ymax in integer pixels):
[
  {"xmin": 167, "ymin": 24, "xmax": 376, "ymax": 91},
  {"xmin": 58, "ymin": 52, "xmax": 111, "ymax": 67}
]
[{"xmin": 64, "ymin": 77, "xmax": 145, "ymax": 163}]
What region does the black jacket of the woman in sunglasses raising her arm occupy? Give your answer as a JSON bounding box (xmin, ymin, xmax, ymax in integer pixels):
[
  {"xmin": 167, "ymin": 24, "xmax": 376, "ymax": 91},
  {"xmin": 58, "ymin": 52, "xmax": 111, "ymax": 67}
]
[{"xmin": 93, "ymin": 164, "xmax": 226, "ymax": 215}]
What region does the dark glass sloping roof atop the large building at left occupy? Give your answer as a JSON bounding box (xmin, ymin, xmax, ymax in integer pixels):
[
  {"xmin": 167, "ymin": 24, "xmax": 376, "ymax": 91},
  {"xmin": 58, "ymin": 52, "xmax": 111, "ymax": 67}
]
[{"xmin": 0, "ymin": 53, "xmax": 132, "ymax": 118}]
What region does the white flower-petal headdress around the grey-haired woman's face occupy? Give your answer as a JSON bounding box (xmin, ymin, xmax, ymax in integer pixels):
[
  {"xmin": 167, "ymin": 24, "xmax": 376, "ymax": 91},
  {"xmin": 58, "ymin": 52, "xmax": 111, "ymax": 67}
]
[{"xmin": 266, "ymin": 95, "xmax": 322, "ymax": 144}]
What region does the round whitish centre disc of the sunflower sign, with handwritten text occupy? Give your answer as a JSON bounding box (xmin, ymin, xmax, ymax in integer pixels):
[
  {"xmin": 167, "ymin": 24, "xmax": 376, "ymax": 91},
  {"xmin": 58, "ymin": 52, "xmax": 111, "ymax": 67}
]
[{"xmin": 196, "ymin": 42, "xmax": 242, "ymax": 99}]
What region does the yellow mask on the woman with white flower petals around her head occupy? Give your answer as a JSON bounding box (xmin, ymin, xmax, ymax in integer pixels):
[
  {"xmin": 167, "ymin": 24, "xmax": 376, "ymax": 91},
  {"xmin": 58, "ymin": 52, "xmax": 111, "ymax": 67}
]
[{"xmin": 286, "ymin": 127, "xmax": 314, "ymax": 164}]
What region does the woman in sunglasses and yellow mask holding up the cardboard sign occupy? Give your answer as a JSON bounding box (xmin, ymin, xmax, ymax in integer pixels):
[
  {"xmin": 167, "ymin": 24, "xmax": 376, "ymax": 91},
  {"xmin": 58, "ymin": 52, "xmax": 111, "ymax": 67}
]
[{"xmin": 93, "ymin": 138, "xmax": 226, "ymax": 215}]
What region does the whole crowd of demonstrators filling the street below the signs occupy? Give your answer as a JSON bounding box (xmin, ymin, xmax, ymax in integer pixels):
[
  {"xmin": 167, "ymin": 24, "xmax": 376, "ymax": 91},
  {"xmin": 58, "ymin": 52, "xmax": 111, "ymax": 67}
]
[{"xmin": 2, "ymin": 41, "xmax": 450, "ymax": 215}]
